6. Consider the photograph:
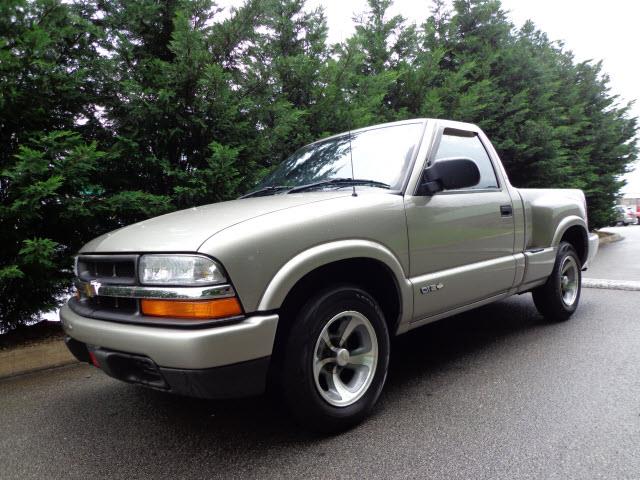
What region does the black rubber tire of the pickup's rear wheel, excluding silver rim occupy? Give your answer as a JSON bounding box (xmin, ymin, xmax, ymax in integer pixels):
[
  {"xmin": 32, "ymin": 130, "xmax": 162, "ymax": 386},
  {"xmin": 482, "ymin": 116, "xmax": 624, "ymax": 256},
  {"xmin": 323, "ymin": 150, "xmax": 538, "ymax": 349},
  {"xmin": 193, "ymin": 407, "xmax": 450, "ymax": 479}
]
[{"xmin": 532, "ymin": 242, "xmax": 582, "ymax": 322}]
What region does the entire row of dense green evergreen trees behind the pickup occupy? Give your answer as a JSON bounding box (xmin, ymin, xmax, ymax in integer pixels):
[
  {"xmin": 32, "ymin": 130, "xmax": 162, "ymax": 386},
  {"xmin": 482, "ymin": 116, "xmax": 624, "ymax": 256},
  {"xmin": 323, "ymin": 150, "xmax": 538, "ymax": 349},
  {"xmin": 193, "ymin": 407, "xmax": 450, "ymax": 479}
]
[{"xmin": 0, "ymin": 0, "xmax": 637, "ymax": 329}]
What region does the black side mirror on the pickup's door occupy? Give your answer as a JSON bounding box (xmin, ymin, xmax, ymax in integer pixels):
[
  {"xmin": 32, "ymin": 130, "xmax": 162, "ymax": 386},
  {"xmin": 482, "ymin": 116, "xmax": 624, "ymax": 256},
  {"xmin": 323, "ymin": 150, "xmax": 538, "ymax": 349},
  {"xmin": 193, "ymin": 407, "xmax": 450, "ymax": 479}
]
[{"xmin": 418, "ymin": 158, "xmax": 480, "ymax": 195}]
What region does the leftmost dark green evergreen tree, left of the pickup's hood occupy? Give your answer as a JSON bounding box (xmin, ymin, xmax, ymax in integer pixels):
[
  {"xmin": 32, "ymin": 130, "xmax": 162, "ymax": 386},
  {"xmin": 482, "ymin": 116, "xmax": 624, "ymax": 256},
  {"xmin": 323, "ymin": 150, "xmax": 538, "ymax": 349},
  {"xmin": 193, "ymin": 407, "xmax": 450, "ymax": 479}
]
[{"xmin": 0, "ymin": 0, "xmax": 109, "ymax": 331}]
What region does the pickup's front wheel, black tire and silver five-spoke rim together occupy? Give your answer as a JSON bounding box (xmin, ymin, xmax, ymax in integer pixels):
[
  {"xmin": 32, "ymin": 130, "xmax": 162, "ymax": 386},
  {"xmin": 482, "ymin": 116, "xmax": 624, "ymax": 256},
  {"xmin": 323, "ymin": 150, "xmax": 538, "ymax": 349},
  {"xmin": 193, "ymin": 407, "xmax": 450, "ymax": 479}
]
[{"xmin": 282, "ymin": 286, "xmax": 389, "ymax": 432}]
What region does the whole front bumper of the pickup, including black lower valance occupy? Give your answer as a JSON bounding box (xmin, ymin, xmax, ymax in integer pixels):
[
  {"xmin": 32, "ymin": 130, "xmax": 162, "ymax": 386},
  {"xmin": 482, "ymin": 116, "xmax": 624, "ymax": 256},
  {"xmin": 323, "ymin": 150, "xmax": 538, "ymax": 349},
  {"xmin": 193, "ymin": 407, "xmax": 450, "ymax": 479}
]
[{"xmin": 60, "ymin": 305, "xmax": 278, "ymax": 398}]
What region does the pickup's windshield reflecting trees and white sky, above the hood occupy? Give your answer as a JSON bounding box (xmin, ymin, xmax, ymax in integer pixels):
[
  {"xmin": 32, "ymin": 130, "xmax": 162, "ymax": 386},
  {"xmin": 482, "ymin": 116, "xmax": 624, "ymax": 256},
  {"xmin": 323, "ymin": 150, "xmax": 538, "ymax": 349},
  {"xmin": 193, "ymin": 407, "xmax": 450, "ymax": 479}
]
[{"xmin": 254, "ymin": 123, "xmax": 423, "ymax": 193}]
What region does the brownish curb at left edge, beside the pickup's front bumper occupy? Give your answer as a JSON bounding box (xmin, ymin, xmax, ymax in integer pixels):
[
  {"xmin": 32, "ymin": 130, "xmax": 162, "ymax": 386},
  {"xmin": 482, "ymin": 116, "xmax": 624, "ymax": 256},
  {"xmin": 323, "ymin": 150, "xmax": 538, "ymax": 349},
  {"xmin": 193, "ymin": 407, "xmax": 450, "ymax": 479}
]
[{"xmin": 0, "ymin": 338, "xmax": 77, "ymax": 378}]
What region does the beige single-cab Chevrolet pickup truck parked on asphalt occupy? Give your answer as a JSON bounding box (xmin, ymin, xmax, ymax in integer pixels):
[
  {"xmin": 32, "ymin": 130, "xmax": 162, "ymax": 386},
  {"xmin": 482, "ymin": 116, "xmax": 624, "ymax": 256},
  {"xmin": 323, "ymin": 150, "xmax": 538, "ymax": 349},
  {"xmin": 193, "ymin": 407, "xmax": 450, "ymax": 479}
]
[{"xmin": 60, "ymin": 119, "xmax": 598, "ymax": 431}]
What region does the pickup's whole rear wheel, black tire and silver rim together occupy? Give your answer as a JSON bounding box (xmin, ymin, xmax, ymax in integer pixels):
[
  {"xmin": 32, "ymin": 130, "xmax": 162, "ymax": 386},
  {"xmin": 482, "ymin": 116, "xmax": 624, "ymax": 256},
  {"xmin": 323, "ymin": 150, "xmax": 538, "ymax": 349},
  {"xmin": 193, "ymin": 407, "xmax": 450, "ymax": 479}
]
[{"xmin": 532, "ymin": 242, "xmax": 582, "ymax": 322}]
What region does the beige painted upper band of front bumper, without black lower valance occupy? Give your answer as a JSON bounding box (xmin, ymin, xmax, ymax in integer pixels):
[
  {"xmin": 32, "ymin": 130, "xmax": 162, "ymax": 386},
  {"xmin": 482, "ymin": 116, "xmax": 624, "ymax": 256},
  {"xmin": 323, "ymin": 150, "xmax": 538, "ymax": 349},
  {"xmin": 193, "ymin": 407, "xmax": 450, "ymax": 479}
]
[{"xmin": 60, "ymin": 305, "xmax": 278, "ymax": 369}]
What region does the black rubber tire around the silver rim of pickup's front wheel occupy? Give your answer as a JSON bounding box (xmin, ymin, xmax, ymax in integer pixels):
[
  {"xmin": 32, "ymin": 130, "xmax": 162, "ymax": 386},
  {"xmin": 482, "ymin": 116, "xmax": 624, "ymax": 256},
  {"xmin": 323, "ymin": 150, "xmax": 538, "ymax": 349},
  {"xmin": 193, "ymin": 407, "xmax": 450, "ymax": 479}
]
[{"xmin": 281, "ymin": 285, "xmax": 390, "ymax": 433}]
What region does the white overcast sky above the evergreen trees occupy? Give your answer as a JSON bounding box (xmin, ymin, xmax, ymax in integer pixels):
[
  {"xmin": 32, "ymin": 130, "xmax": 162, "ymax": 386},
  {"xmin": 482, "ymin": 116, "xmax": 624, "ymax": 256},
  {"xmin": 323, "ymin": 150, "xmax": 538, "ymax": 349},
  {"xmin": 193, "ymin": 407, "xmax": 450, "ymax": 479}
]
[{"xmin": 224, "ymin": 0, "xmax": 640, "ymax": 196}]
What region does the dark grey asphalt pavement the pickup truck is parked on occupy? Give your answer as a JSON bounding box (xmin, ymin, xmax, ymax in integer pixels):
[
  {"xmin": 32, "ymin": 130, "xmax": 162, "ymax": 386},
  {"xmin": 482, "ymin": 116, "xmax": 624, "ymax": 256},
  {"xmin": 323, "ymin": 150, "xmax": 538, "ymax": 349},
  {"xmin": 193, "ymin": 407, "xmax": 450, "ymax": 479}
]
[{"xmin": 0, "ymin": 240, "xmax": 640, "ymax": 480}]
